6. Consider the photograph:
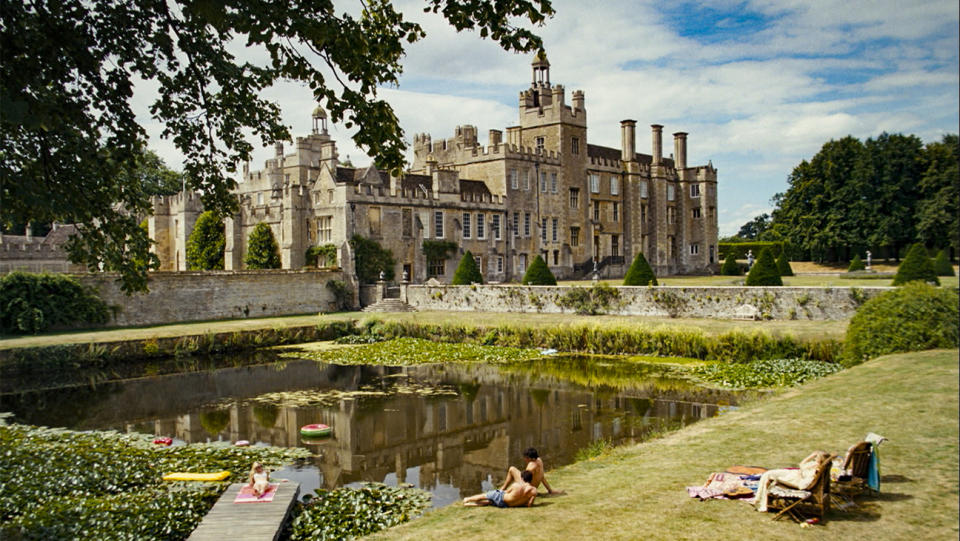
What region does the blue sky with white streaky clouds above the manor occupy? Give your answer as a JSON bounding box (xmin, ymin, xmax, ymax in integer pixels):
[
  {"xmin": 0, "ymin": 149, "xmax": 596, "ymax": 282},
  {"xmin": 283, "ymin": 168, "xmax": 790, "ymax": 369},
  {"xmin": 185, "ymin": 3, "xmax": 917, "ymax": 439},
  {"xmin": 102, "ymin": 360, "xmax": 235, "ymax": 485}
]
[{"xmin": 141, "ymin": 0, "xmax": 960, "ymax": 236}]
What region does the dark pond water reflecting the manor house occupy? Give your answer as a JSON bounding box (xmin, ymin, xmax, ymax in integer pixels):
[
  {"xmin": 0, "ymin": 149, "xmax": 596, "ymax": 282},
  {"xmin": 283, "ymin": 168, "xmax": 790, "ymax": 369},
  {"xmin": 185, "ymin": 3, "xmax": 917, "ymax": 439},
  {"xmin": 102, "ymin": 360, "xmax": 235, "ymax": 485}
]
[{"xmin": 0, "ymin": 355, "xmax": 743, "ymax": 507}]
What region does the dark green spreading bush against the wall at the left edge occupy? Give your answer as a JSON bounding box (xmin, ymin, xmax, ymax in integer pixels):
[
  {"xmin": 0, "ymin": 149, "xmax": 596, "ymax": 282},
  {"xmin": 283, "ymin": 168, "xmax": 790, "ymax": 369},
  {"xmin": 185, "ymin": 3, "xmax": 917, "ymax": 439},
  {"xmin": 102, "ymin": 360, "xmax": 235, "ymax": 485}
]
[{"xmin": 0, "ymin": 271, "xmax": 110, "ymax": 334}]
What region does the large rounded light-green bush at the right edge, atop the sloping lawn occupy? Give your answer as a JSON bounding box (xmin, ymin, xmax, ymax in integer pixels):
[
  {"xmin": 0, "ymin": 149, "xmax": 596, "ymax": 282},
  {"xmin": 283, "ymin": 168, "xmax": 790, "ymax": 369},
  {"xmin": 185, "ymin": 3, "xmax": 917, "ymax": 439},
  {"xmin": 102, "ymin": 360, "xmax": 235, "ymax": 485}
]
[{"xmin": 843, "ymin": 281, "xmax": 960, "ymax": 364}]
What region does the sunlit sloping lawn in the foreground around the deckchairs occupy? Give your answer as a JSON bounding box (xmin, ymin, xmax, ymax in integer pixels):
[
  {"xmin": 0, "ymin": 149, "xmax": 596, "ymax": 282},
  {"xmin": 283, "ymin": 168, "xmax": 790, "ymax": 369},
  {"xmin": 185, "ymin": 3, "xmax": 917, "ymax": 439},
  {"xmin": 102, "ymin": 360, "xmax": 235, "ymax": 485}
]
[{"xmin": 374, "ymin": 350, "xmax": 960, "ymax": 541}]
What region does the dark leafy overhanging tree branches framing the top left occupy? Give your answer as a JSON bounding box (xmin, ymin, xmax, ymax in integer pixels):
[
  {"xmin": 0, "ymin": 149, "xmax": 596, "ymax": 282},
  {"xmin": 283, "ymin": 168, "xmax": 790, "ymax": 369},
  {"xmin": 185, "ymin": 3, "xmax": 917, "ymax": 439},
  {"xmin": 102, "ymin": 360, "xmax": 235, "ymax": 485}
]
[{"xmin": 0, "ymin": 0, "xmax": 553, "ymax": 291}]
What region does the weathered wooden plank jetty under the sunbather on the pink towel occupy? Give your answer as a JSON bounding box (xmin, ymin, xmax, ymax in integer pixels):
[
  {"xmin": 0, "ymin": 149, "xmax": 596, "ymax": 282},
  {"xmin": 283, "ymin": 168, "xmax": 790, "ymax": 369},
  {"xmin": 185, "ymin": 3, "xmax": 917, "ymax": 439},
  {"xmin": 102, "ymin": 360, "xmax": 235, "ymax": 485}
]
[{"xmin": 189, "ymin": 482, "xmax": 300, "ymax": 541}]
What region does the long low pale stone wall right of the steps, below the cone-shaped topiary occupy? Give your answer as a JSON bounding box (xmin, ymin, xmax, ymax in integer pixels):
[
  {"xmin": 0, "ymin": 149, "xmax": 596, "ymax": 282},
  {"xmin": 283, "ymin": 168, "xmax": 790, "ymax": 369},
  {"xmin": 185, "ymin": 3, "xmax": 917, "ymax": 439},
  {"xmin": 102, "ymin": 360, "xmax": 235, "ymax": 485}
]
[{"xmin": 407, "ymin": 285, "xmax": 892, "ymax": 320}]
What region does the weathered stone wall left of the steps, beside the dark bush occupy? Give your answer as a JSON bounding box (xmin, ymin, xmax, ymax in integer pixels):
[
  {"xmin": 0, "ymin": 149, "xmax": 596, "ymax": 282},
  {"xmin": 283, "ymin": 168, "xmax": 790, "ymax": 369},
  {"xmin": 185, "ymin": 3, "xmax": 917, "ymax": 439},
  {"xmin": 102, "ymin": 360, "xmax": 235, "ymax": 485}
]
[{"xmin": 77, "ymin": 270, "xmax": 344, "ymax": 326}]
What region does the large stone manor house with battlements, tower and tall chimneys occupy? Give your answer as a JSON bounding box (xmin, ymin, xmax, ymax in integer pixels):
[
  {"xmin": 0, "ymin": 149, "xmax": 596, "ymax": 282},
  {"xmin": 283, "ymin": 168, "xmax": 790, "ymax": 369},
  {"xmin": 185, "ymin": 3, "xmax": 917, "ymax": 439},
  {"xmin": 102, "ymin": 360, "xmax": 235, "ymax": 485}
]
[{"xmin": 149, "ymin": 56, "xmax": 718, "ymax": 282}]
